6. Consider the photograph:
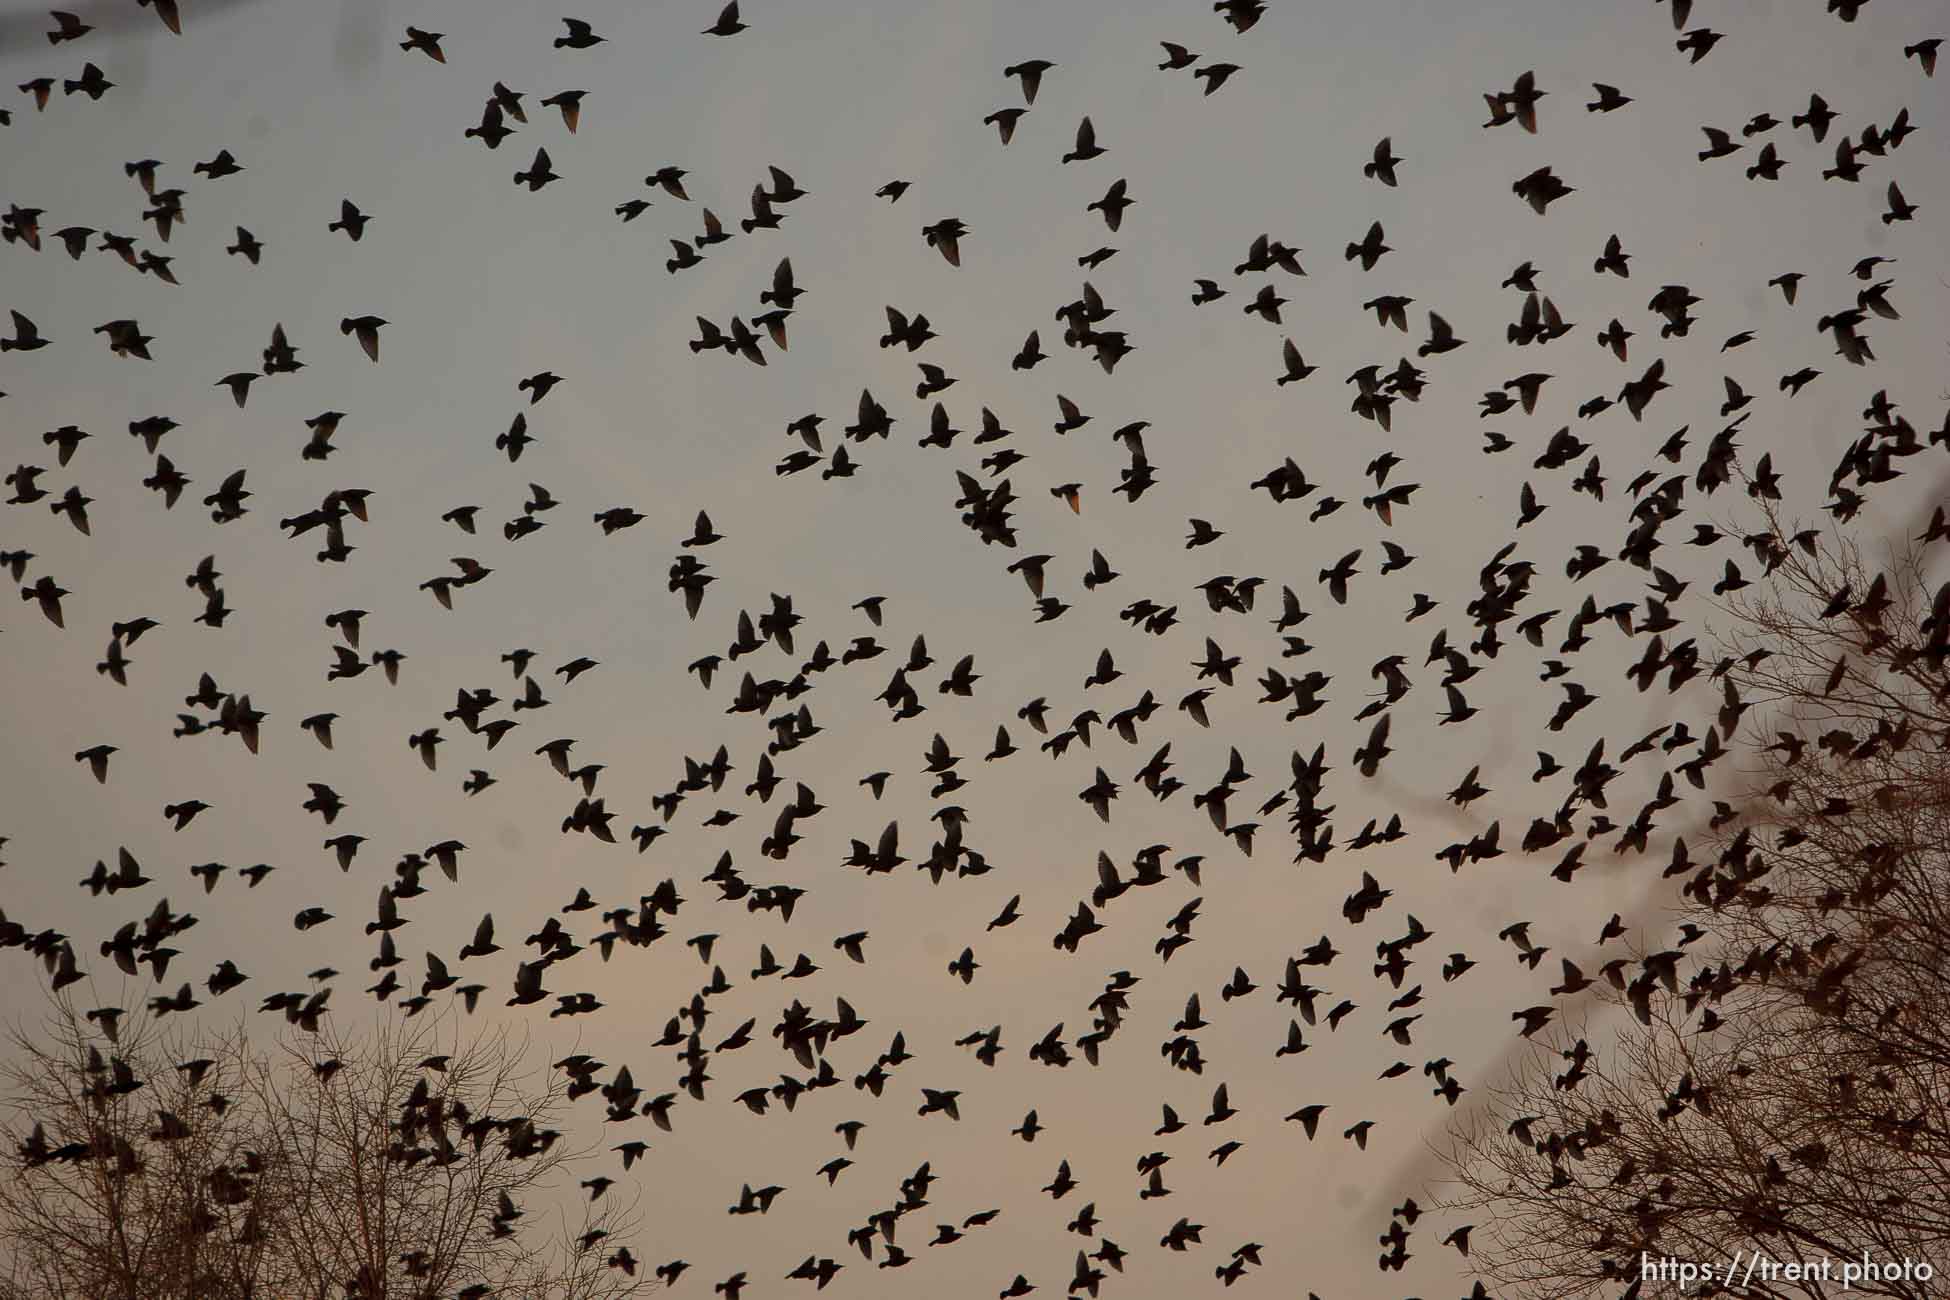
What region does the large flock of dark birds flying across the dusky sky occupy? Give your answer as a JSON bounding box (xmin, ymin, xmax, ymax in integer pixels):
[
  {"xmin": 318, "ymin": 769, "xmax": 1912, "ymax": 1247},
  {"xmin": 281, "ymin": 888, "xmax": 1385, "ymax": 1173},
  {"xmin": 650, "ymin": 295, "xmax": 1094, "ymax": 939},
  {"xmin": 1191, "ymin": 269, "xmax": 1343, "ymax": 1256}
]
[{"xmin": 0, "ymin": 0, "xmax": 1950, "ymax": 1300}]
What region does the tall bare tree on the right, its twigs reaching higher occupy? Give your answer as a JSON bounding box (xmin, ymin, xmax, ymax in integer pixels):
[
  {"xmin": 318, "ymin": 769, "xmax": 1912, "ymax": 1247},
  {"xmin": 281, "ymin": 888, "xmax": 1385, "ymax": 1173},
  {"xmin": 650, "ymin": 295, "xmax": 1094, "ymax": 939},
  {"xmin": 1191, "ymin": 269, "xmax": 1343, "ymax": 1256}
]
[{"xmin": 1447, "ymin": 497, "xmax": 1950, "ymax": 1300}]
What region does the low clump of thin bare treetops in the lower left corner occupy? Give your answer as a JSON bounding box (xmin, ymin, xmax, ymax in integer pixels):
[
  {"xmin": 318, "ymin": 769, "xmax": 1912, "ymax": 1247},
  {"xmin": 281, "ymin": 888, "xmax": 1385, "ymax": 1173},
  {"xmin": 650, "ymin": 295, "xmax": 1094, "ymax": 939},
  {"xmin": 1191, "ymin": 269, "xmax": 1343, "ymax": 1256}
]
[{"xmin": 0, "ymin": 996, "xmax": 649, "ymax": 1300}]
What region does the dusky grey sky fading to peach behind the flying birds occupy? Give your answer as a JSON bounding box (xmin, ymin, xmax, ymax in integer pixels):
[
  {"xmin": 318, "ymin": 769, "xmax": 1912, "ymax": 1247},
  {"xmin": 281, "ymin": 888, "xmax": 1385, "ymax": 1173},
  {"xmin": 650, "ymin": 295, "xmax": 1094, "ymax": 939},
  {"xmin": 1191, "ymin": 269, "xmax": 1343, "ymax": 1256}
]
[{"xmin": 0, "ymin": 0, "xmax": 1950, "ymax": 1300}]
